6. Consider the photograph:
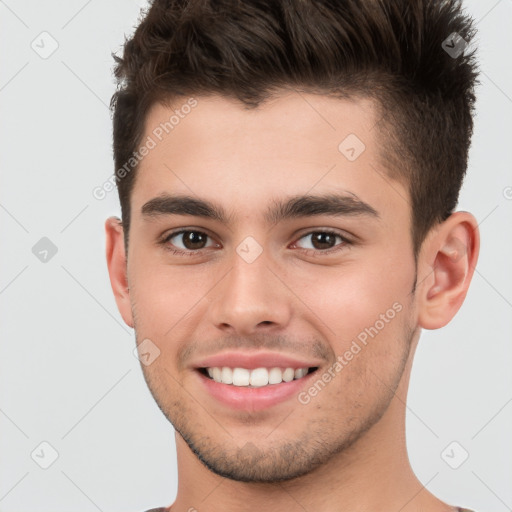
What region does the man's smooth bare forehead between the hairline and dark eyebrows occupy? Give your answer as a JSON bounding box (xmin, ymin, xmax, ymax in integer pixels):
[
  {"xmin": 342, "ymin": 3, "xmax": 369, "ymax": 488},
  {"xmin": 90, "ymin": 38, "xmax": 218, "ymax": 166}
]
[{"xmin": 132, "ymin": 92, "xmax": 408, "ymax": 224}]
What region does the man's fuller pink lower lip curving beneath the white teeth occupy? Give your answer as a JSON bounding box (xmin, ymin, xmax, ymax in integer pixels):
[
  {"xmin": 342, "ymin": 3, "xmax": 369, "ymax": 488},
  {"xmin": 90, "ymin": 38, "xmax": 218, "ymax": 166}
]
[{"xmin": 196, "ymin": 370, "xmax": 317, "ymax": 411}]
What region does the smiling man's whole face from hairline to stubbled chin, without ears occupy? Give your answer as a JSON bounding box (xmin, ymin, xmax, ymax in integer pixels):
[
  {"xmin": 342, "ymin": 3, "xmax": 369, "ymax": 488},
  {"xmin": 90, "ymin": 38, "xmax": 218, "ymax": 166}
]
[{"xmin": 122, "ymin": 94, "xmax": 417, "ymax": 481}]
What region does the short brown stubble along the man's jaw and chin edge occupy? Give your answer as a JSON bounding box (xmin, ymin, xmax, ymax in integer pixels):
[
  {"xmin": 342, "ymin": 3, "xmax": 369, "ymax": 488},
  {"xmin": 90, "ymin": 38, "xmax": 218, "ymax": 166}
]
[{"xmin": 130, "ymin": 272, "xmax": 417, "ymax": 484}]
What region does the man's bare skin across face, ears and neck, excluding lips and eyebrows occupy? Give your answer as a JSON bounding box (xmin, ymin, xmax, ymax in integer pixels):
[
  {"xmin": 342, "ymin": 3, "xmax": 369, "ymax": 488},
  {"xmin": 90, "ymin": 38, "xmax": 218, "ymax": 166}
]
[{"xmin": 106, "ymin": 91, "xmax": 479, "ymax": 512}]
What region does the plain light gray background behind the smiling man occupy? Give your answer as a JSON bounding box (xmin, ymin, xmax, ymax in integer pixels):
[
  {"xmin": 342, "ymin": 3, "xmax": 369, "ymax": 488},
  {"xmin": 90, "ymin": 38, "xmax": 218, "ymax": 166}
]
[{"xmin": 0, "ymin": 0, "xmax": 512, "ymax": 512}]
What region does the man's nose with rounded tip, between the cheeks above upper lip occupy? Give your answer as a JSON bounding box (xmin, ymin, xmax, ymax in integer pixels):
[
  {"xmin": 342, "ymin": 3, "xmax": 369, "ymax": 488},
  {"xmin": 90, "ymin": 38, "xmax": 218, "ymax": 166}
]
[{"xmin": 209, "ymin": 248, "xmax": 292, "ymax": 336}]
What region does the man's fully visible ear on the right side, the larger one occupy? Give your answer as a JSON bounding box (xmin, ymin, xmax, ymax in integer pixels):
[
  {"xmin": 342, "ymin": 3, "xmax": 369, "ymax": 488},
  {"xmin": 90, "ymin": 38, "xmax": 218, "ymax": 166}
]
[{"xmin": 417, "ymin": 212, "xmax": 480, "ymax": 329}]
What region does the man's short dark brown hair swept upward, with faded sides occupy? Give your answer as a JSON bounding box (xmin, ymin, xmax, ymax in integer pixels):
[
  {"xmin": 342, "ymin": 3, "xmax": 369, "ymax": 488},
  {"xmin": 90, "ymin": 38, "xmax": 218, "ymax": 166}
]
[{"xmin": 111, "ymin": 0, "xmax": 477, "ymax": 256}]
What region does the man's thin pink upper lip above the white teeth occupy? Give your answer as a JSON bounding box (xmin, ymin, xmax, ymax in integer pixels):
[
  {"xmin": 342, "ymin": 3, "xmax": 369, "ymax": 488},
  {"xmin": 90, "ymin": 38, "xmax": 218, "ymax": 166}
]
[{"xmin": 192, "ymin": 351, "xmax": 320, "ymax": 370}]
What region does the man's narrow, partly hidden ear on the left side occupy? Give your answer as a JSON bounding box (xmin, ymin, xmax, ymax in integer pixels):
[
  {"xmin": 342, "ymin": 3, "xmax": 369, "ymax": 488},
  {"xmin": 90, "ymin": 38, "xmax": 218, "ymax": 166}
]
[{"xmin": 105, "ymin": 217, "xmax": 133, "ymax": 327}]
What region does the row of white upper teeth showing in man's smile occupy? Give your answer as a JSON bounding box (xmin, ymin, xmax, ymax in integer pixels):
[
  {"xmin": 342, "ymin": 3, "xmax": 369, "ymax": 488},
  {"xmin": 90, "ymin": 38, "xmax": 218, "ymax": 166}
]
[{"xmin": 206, "ymin": 366, "xmax": 308, "ymax": 388}]
